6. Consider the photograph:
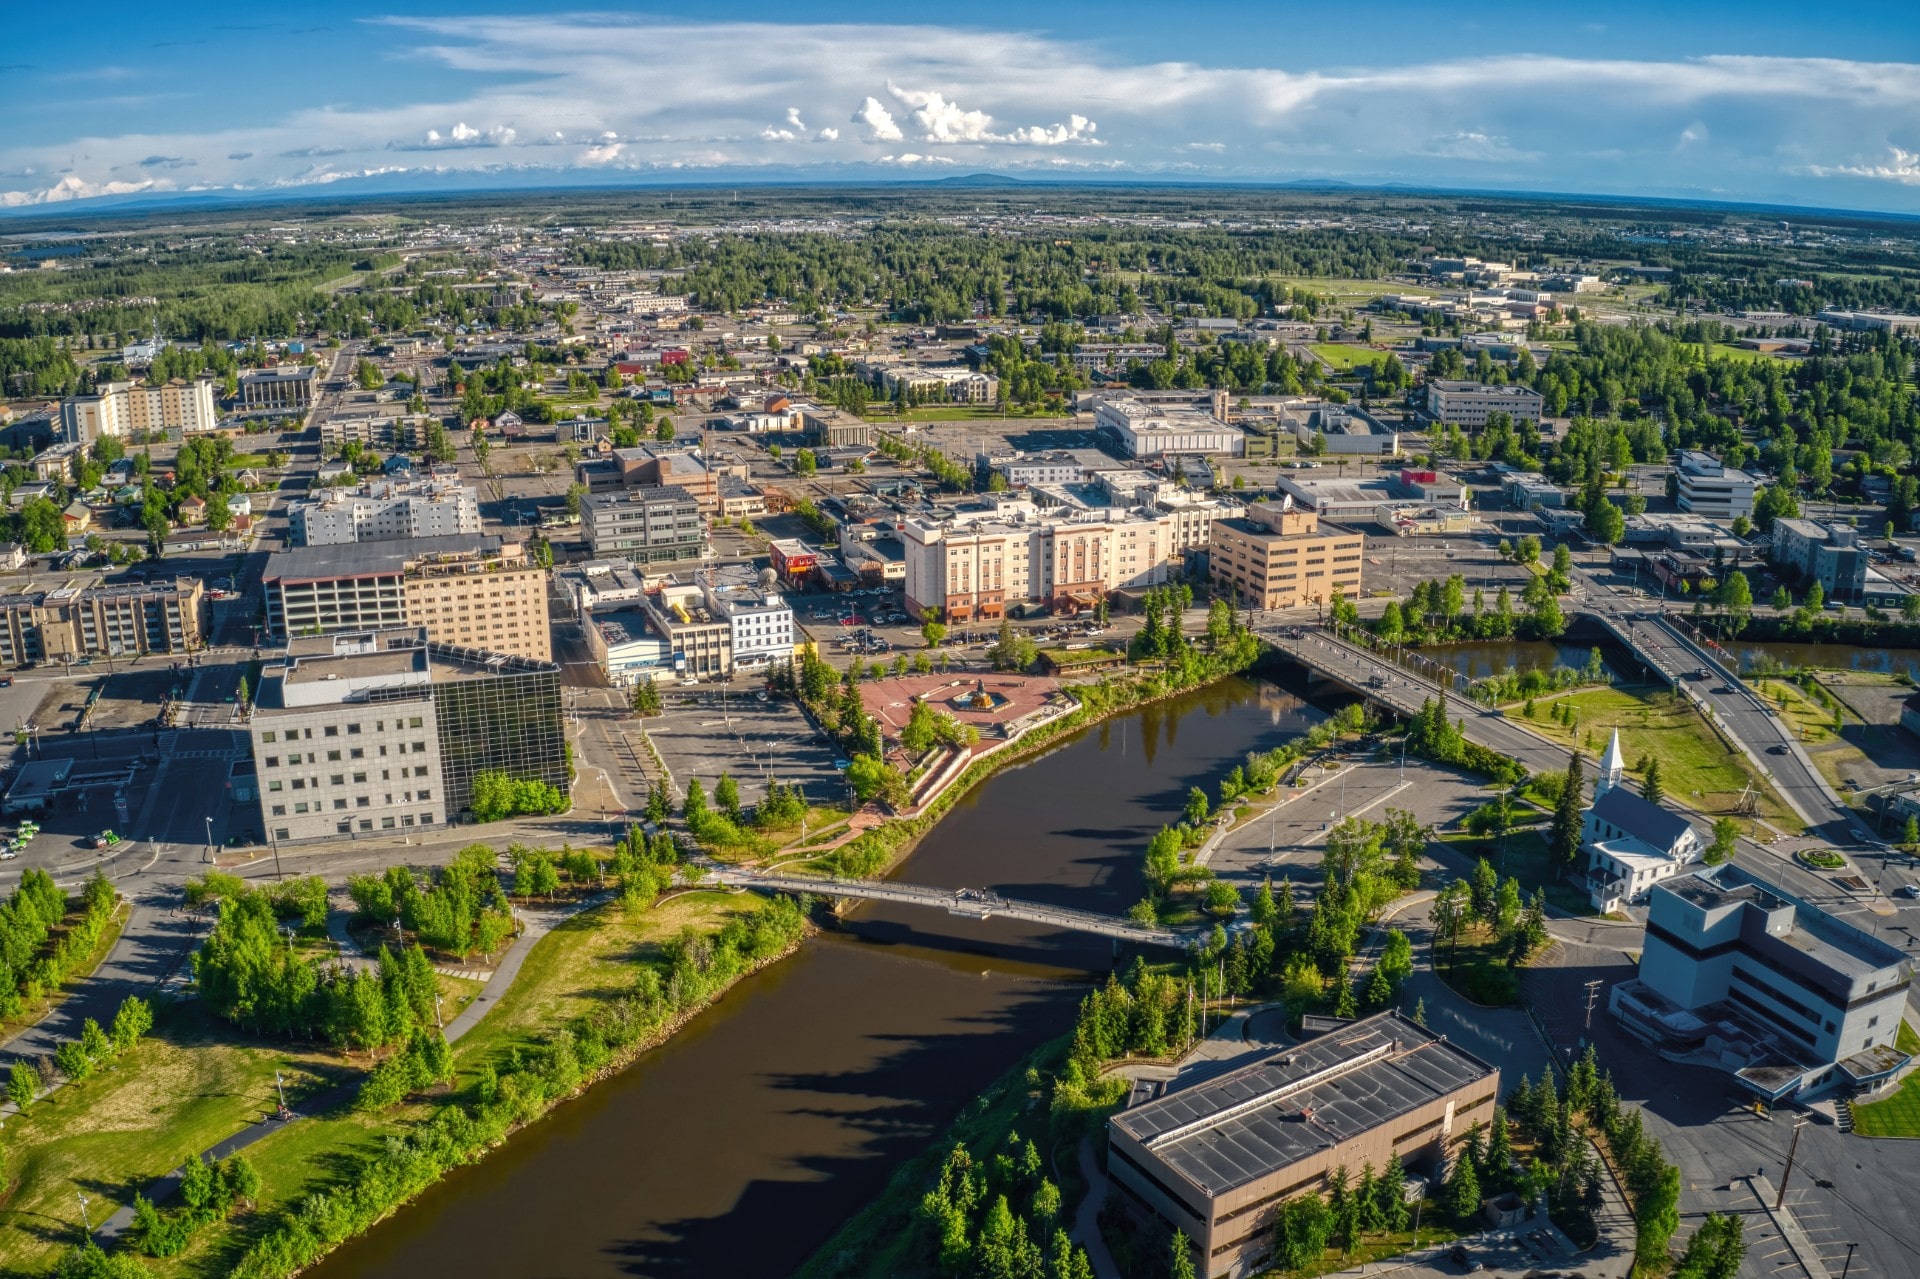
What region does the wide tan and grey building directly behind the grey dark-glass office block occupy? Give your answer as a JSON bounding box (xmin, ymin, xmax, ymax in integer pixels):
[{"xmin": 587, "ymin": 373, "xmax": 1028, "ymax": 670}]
[{"xmin": 261, "ymin": 534, "xmax": 553, "ymax": 663}]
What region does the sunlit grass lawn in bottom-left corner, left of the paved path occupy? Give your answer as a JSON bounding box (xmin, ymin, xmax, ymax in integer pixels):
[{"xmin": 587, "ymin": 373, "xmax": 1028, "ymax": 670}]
[{"xmin": 0, "ymin": 1002, "xmax": 353, "ymax": 1275}]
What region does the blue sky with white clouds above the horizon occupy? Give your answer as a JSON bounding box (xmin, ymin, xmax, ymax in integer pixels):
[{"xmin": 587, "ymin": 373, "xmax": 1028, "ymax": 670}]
[{"xmin": 11, "ymin": 0, "xmax": 1920, "ymax": 213}]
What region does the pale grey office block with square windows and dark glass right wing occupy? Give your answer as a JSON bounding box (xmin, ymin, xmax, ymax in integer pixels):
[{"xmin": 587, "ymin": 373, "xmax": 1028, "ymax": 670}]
[{"xmin": 248, "ymin": 628, "xmax": 568, "ymax": 843}]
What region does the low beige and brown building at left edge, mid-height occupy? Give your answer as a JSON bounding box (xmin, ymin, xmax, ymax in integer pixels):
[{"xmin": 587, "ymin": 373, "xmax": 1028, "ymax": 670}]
[{"xmin": 0, "ymin": 578, "xmax": 207, "ymax": 666}]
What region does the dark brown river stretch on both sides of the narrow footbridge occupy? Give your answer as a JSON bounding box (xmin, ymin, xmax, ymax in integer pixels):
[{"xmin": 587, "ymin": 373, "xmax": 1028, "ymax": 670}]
[{"xmin": 315, "ymin": 680, "xmax": 1319, "ymax": 1279}]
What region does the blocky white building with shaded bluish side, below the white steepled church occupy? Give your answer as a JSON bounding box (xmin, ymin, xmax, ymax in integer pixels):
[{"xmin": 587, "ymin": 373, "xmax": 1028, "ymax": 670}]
[{"xmin": 1609, "ymin": 864, "xmax": 1912, "ymax": 1100}]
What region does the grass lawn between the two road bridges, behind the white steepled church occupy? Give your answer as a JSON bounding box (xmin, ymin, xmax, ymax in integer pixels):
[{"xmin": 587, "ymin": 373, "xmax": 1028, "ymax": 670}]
[{"xmin": 1507, "ymin": 688, "xmax": 1801, "ymax": 832}]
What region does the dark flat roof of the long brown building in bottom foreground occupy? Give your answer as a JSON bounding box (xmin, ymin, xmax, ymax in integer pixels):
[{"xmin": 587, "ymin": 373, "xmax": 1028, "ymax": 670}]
[{"xmin": 1112, "ymin": 1012, "xmax": 1500, "ymax": 1196}]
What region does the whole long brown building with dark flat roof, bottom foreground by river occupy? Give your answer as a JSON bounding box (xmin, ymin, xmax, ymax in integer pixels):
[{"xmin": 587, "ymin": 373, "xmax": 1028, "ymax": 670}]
[{"xmin": 1106, "ymin": 1012, "xmax": 1500, "ymax": 1279}]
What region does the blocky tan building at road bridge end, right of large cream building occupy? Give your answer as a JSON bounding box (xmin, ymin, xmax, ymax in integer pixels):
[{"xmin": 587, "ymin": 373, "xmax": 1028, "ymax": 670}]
[{"xmin": 1208, "ymin": 499, "xmax": 1367, "ymax": 609}]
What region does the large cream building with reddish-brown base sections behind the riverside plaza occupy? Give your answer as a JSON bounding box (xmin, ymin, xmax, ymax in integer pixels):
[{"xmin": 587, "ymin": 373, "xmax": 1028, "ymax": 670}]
[{"xmin": 900, "ymin": 501, "xmax": 1175, "ymax": 622}]
